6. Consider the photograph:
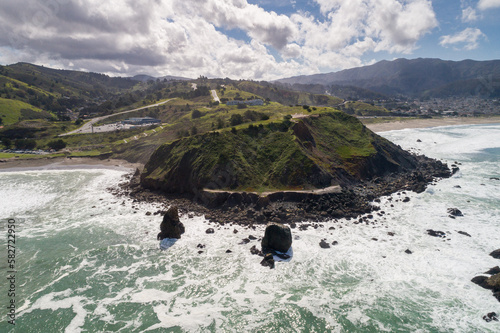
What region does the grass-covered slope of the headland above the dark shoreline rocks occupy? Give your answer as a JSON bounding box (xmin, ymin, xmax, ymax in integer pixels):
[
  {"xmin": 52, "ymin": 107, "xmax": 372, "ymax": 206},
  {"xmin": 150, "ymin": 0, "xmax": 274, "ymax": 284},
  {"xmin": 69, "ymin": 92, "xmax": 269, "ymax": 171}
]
[{"xmin": 141, "ymin": 112, "xmax": 417, "ymax": 193}]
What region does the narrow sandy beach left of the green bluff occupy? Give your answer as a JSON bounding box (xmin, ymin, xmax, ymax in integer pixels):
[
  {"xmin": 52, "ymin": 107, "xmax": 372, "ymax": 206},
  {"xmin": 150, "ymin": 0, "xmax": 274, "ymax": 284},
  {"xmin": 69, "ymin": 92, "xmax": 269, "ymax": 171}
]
[{"xmin": 0, "ymin": 157, "xmax": 143, "ymax": 172}]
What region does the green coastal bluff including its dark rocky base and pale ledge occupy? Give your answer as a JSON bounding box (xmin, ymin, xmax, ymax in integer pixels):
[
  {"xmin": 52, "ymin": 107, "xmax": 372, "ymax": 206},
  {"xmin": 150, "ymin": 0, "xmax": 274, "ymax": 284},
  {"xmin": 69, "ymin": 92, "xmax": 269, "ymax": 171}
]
[{"xmin": 135, "ymin": 112, "xmax": 451, "ymax": 223}]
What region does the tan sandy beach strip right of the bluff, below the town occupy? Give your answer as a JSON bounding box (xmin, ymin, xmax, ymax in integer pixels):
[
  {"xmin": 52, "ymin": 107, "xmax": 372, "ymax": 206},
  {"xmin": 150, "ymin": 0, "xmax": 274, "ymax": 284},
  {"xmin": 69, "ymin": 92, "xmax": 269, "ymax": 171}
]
[{"xmin": 366, "ymin": 116, "xmax": 500, "ymax": 133}]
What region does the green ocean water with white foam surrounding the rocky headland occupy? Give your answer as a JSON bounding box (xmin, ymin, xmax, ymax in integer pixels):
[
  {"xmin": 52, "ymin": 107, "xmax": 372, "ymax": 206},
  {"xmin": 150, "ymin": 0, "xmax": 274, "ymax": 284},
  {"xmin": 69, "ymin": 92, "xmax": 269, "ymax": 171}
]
[{"xmin": 0, "ymin": 125, "xmax": 500, "ymax": 333}]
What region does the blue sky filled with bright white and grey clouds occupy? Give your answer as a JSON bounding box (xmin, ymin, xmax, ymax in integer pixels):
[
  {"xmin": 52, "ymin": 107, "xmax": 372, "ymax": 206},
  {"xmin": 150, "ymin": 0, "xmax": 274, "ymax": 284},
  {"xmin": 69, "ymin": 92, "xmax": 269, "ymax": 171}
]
[{"xmin": 0, "ymin": 0, "xmax": 500, "ymax": 80}]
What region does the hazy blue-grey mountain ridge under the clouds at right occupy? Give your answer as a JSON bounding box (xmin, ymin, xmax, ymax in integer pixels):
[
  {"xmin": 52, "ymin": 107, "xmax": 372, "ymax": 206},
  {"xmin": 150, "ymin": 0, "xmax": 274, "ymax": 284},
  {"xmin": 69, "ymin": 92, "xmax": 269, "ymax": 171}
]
[{"xmin": 277, "ymin": 58, "xmax": 500, "ymax": 97}]
